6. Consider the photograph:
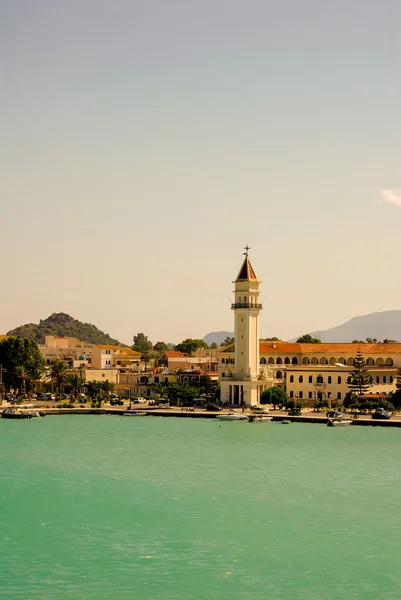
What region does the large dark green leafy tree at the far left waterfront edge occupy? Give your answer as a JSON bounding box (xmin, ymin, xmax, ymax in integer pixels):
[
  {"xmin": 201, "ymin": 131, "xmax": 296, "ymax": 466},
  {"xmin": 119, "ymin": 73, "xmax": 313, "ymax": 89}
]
[{"xmin": 0, "ymin": 336, "xmax": 45, "ymax": 389}]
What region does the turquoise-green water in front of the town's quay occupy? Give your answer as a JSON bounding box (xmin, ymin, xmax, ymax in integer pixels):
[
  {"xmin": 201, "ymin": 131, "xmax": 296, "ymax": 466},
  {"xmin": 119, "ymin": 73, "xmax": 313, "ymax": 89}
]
[{"xmin": 0, "ymin": 415, "xmax": 401, "ymax": 600}]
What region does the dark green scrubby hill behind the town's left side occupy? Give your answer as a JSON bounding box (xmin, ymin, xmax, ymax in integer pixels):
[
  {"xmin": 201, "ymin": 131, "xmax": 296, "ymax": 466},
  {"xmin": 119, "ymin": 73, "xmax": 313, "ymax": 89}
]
[{"xmin": 7, "ymin": 313, "xmax": 124, "ymax": 346}]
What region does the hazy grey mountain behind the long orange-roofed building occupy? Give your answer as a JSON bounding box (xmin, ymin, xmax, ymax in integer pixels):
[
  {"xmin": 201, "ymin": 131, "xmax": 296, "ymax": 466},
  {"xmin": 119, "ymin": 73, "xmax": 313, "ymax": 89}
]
[{"xmin": 291, "ymin": 310, "xmax": 401, "ymax": 342}]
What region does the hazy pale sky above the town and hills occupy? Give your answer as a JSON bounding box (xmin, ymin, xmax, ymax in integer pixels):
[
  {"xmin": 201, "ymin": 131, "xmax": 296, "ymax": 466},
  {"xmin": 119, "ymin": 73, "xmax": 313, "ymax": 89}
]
[{"xmin": 0, "ymin": 0, "xmax": 401, "ymax": 343}]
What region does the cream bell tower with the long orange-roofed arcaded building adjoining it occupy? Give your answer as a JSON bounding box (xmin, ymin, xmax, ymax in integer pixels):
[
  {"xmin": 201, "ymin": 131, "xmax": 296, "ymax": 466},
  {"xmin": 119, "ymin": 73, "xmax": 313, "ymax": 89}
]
[{"xmin": 218, "ymin": 249, "xmax": 401, "ymax": 406}]
